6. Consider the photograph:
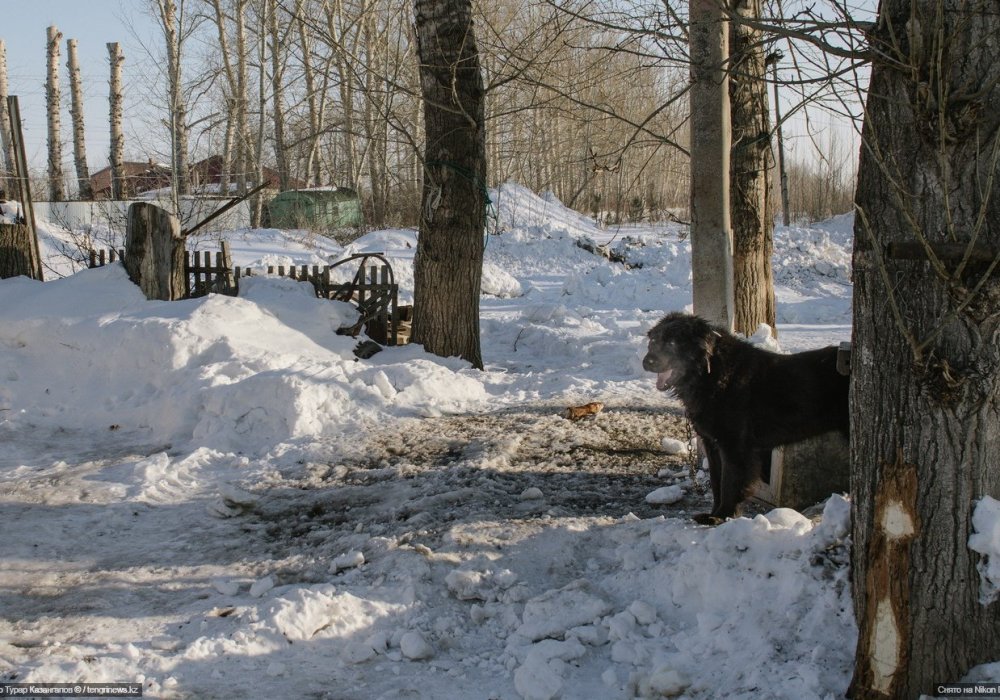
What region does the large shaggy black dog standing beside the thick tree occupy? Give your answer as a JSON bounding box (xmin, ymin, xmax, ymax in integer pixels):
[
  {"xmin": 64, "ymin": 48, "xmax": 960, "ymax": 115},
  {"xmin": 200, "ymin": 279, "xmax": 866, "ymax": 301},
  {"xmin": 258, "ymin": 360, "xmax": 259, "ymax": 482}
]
[{"xmin": 642, "ymin": 313, "xmax": 849, "ymax": 524}]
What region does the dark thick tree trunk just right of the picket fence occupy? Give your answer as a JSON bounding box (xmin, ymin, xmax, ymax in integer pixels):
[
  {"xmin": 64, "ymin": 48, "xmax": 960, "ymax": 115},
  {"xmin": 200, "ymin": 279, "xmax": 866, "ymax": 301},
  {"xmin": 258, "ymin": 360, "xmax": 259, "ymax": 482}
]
[{"xmin": 413, "ymin": 0, "xmax": 486, "ymax": 369}]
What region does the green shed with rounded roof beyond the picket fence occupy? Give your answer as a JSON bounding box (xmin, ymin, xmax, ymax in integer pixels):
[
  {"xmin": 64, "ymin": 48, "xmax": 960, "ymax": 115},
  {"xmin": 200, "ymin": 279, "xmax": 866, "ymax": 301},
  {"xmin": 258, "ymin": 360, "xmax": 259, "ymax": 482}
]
[{"xmin": 267, "ymin": 187, "xmax": 364, "ymax": 231}]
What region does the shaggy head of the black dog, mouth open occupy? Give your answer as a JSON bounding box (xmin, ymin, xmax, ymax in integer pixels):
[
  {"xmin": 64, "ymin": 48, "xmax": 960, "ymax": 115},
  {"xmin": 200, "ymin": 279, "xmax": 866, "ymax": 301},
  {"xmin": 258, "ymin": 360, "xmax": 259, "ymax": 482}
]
[{"xmin": 642, "ymin": 312, "xmax": 720, "ymax": 391}]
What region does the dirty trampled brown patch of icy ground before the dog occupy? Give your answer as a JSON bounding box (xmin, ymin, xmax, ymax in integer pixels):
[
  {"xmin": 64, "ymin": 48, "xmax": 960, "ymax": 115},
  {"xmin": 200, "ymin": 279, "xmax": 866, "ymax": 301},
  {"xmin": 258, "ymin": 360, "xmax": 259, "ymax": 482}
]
[{"xmin": 251, "ymin": 405, "xmax": 711, "ymax": 580}]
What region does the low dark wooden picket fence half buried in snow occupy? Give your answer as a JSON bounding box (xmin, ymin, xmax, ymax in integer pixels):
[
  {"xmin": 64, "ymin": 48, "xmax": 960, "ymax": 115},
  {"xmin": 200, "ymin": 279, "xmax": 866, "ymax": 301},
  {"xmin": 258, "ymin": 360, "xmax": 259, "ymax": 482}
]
[{"xmin": 90, "ymin": 242, "xmax": 409, "ymax": 345}]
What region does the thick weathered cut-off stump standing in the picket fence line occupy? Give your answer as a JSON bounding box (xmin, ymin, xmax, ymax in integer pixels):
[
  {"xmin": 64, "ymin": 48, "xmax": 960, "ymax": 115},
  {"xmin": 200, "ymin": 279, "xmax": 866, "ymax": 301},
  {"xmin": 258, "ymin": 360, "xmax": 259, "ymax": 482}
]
[{"xmin": 124, "ymin": 202, "xmax": 188, "ymax": 301}]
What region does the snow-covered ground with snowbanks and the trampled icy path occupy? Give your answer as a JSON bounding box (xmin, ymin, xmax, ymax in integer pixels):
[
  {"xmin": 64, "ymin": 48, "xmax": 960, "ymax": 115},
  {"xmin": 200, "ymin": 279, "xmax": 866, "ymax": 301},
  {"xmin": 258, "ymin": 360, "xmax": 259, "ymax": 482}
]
[{"xmin": 0, "ymin": 186, "xmax": 876, "ymax": 700}]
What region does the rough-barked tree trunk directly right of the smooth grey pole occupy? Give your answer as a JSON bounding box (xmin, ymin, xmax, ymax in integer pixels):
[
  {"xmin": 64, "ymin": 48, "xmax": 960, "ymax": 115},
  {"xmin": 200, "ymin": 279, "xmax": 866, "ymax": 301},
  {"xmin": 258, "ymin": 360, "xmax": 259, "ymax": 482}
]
[{"xmin": 729, "ymin": 0, "xmax": 777, "ymax": 335}]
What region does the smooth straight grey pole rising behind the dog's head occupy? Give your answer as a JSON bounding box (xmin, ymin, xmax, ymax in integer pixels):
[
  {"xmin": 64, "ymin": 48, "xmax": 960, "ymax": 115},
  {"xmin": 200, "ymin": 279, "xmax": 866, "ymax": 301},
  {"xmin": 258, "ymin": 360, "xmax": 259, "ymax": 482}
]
[{"xmin": 689, "ymin": 0, "xmax": 733, "ymax": 328}]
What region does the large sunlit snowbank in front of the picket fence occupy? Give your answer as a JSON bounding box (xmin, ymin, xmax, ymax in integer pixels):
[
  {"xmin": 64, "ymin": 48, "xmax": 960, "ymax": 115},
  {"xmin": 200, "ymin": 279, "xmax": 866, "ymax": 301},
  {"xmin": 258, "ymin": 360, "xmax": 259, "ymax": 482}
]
[{"xmin": 0, "ymin": 265, "xmax": 486, "ymax": 453}]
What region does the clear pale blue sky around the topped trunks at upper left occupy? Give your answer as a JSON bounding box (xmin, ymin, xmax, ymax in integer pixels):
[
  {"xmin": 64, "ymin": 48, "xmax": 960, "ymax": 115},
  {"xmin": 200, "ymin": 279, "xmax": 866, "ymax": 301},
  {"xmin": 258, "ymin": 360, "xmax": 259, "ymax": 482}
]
[{"xmin": 0, "ymin": 0, "xmax": 153, "ymax": 174}]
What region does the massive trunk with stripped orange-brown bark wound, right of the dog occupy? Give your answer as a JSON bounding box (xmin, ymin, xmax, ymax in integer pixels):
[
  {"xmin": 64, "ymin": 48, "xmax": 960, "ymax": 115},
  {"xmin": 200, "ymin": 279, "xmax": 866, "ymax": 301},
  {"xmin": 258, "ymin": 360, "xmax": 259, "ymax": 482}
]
[{"xmin": 851, "ymin": 0, "xmax": 1000, "ymax": 698}]
